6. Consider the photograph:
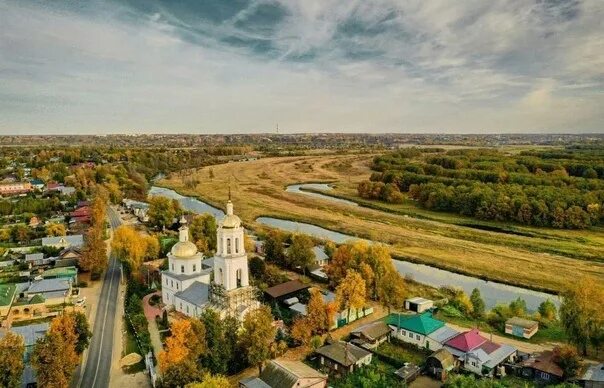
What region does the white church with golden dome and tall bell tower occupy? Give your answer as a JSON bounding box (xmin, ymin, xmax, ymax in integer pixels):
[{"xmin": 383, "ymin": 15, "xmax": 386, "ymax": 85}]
[{"xmin": 162, "ymin": 199, "xmax": 259, "ymax": 319}]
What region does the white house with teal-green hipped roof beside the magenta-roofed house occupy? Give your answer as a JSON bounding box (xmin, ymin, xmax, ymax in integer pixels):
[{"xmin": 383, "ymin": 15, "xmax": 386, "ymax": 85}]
[{"xmin": 386, "ymin": 312, "xmax": 458, "ymax": 350}]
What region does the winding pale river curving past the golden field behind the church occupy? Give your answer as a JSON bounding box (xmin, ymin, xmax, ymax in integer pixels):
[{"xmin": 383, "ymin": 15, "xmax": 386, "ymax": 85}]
[{"xmin": 149, "ymin": 184, "xmax": 560, "ymax": 311}]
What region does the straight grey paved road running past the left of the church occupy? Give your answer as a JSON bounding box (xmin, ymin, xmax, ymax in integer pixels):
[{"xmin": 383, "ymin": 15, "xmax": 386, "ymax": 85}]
[{"xmin": 78, "ymin": 208, "xmax": 121, "ymax": 388}]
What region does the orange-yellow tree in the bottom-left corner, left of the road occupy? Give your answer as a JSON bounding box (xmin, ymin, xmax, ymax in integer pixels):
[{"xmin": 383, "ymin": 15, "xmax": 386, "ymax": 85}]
[{"xmin": 0, "ymin": 331, "xmax": 25, "ymax": 388}]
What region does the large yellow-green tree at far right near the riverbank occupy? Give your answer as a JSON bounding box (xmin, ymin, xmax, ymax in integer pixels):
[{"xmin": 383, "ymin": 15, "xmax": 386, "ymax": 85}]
[{"xmin": 560, "ymin": 277, "xmax": 604, "ymax": 355}]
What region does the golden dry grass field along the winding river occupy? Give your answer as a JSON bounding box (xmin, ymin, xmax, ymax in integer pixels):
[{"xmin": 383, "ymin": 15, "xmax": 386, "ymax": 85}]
[{"xmin": 159, "ymin": 155, "xmax": 604, "ymax": 291}]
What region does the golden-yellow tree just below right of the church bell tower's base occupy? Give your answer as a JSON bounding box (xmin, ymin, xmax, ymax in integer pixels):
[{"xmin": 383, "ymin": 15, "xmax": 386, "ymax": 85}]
[{"xmin": 240, "ymin": 306, "xmax": 277, "ymax": 372}]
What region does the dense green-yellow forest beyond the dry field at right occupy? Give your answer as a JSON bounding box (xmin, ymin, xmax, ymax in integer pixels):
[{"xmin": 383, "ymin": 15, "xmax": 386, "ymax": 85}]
[{"xmin": 358, "ymin": 144, "xmax": 604, "ymax": 229}]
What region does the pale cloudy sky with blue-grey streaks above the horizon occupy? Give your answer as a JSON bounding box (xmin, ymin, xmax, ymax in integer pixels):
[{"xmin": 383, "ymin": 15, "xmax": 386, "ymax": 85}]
[{"xmin": 0, "ymin": 0, "xmax": 604, "ymax": 135}]
